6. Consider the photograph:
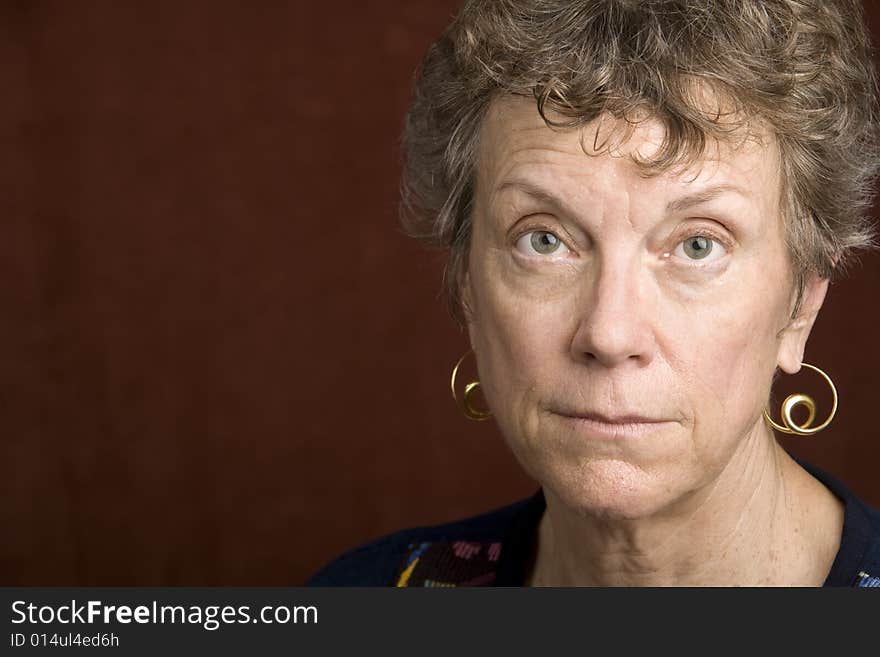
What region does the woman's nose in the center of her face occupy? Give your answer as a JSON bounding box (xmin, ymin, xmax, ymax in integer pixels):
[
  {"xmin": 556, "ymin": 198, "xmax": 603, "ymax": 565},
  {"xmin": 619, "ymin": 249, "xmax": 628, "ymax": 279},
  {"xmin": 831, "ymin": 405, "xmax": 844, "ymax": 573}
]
[{"xmin": 571, "ymin": 251, "xmax": 657, "ymax": 368}]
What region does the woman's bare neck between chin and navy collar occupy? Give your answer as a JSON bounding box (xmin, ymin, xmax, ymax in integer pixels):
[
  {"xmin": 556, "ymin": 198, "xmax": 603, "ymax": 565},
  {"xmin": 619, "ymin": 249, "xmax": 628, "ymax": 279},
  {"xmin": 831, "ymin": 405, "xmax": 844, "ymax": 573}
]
[{"xmin": 526, "ymin": 423, "xmax": 843, "ymax": 586}]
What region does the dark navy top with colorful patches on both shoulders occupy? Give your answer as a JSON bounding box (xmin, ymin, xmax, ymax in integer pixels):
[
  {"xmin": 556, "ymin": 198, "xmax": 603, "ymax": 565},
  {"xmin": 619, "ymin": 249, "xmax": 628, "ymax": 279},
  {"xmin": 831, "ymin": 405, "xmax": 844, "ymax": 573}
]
[{"xmin": 306, "ymin": 461, "xmax": 880, "ymax": 587}]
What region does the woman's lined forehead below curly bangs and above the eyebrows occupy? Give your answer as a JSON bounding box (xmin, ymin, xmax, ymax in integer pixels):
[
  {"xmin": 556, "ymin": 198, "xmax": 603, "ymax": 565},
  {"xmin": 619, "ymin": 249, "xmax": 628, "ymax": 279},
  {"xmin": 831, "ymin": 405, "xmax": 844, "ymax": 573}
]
[{"xmin": 477, "ymin": 96, "xmax": 780, "ymax": 198}]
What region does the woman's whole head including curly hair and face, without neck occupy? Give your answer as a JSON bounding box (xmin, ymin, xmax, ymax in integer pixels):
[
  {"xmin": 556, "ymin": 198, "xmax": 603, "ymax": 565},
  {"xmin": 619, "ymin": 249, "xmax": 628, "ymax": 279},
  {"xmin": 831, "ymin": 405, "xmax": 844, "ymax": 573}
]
[{"xmin": 404, "ymin": 0, "xmax": 877, "ymax": 517}]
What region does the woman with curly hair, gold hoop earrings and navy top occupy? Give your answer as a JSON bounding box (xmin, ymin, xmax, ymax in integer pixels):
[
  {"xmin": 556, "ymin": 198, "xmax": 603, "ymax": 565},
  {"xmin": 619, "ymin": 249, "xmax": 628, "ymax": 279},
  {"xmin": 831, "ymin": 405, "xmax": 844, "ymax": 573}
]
[{"xmin": 310, "ymin": 0, "xmax": 880, "ymax": 586}]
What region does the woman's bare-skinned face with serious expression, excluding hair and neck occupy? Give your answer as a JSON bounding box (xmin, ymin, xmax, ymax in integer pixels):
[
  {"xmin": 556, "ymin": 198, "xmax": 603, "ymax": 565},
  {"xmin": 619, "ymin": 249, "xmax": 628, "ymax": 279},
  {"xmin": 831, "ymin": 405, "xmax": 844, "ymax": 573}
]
[{"xmin": 463, "ymin": 98, "xmax": 825, "ymax": 518}]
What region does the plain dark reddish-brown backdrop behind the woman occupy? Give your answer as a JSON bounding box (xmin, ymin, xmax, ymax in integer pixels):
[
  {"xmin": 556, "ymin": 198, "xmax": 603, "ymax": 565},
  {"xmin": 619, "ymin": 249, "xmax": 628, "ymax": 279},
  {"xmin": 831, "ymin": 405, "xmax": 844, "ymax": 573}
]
[{"xmin": 0, "ymin": 0, "xmax": 880, "ymax": 585}]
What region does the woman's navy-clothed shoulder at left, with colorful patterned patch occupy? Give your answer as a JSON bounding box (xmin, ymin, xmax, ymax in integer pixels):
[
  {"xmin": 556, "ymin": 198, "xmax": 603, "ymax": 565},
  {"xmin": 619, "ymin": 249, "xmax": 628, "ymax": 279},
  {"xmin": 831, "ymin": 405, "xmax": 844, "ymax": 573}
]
[{"xmin": 306, "ymin": 499, "xmax": 529, "ymax": 586}]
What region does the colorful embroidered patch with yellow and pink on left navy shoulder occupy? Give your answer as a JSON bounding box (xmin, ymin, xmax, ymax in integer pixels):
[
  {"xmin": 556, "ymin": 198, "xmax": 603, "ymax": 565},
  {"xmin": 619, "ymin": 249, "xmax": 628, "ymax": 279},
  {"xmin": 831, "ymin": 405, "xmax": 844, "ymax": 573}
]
[{"xmin": 396, "ymin": 541, "xmax": 501, "ymax": 587}]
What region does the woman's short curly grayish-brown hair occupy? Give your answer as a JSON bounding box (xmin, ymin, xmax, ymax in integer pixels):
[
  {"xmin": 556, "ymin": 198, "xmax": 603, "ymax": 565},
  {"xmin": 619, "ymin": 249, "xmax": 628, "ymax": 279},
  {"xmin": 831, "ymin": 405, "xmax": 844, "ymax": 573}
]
[{"xmin": 401, "ymin": 0, "xmax": 880, "ymax": 323}]
